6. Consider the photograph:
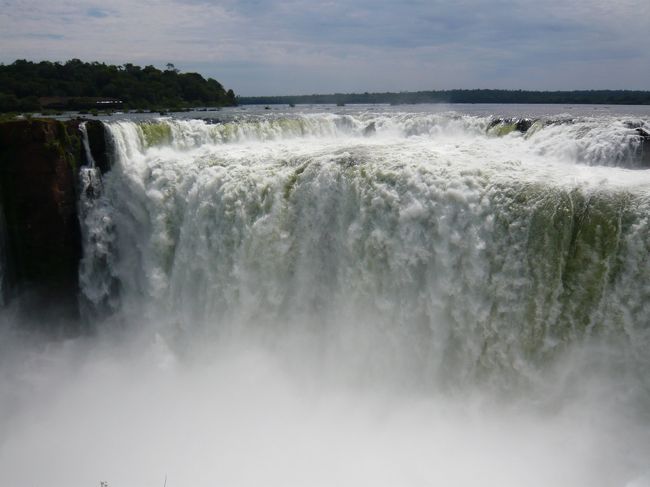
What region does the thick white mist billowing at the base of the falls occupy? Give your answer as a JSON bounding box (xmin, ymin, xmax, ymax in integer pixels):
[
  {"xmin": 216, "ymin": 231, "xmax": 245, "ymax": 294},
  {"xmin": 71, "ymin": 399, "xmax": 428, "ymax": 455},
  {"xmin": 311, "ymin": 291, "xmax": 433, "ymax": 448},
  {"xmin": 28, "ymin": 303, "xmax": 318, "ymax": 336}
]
[{"xmin": 0, "ymin": 310, "xmax": 650, "ymax": 487}]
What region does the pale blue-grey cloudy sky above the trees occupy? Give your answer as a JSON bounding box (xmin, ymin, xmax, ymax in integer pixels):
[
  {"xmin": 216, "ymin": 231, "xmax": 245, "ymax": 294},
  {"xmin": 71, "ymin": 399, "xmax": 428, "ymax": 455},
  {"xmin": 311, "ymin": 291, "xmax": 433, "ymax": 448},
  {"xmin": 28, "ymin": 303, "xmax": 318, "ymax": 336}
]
[{"xmin": 0, "ymin": 0, "xmax": 650, "ymax": 96}]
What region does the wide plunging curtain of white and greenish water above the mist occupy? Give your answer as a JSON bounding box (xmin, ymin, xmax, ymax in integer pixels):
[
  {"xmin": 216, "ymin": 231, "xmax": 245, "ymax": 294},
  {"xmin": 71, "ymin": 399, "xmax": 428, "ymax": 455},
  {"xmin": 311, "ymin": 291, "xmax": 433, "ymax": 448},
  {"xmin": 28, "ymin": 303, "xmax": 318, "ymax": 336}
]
[{"xmin": 73, "ymin": 115, "xmax": 650, "ymax": 388}]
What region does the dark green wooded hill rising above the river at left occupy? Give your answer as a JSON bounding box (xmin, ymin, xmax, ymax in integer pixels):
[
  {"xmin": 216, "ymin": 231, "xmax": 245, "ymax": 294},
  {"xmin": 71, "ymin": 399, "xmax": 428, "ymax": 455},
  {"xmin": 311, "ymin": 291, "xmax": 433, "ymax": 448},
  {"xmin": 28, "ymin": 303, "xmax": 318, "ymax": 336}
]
[{"xmin": 0, "ymin": 59, "xmax": 236, "ymax": 112}]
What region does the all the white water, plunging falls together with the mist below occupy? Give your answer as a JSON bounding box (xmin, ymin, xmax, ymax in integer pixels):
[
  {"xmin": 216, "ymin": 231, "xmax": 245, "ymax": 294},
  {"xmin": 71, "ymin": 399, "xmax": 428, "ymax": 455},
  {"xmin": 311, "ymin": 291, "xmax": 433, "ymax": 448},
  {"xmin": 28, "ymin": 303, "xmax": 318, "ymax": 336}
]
[{"xmin": 0, "ymin": 113, "xmax": 650, "ymax": 486}]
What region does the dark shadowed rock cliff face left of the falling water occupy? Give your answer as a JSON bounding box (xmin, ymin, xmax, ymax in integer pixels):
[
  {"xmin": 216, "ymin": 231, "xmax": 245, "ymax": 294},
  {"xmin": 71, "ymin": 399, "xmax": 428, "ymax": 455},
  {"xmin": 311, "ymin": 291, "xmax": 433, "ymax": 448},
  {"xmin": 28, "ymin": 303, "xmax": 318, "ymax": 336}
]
[{"xmin": 0, "ymin": 120, "xmax": 83, "ymax": 319}]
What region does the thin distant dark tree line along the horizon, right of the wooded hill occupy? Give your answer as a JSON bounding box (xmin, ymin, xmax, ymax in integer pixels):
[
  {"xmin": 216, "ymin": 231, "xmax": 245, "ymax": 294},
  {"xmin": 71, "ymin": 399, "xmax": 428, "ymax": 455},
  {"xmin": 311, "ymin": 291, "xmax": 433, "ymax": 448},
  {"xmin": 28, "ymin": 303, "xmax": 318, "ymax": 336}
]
[{"xmin": 238, "ymin": 90, "xmax": 650, "ymax": 105}]
